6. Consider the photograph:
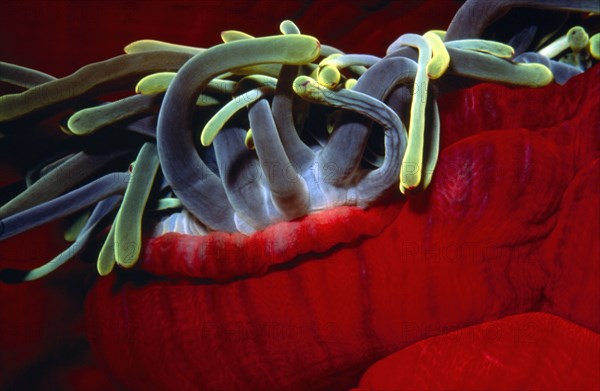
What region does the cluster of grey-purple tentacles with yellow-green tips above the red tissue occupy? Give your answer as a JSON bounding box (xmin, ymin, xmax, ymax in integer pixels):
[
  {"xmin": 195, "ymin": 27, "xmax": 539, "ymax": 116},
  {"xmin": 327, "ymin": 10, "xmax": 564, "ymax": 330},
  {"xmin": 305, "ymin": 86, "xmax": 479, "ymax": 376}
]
[{"xmin": 0, "ymin": 2, "xmax": 600, "ymax": 282}]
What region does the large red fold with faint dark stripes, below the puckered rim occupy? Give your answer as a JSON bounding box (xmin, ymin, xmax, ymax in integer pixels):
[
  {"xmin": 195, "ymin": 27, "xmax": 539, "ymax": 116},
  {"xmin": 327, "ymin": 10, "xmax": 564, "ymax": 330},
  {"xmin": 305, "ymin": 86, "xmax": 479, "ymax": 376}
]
[{"xmin": 87, "ymin": 67, "xmax": 600, "ymax": 390}]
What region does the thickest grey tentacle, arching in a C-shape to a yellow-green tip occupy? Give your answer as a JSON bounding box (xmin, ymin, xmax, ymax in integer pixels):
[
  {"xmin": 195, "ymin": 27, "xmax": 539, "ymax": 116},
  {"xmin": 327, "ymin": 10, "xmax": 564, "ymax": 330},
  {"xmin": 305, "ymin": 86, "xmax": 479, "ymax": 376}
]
[{"xmin": 157, "ymin": 35, "xmax": 319, "ymax": 232}]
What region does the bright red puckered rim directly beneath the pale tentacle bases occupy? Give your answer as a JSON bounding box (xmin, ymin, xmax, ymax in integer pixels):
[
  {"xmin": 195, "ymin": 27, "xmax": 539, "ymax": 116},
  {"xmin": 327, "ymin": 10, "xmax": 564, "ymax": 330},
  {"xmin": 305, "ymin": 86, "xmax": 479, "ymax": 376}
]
[{"xmin": 139, "ymin": 202, "xmax": 403, "ymax": 283}]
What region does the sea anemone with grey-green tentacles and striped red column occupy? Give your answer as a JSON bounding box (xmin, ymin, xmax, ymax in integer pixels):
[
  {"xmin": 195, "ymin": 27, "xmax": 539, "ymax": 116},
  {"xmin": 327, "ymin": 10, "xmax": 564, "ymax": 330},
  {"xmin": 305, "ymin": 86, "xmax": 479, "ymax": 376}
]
[{"xmin": 0, "ymin": 1, "xmax": 600, "ymax": 389}]
